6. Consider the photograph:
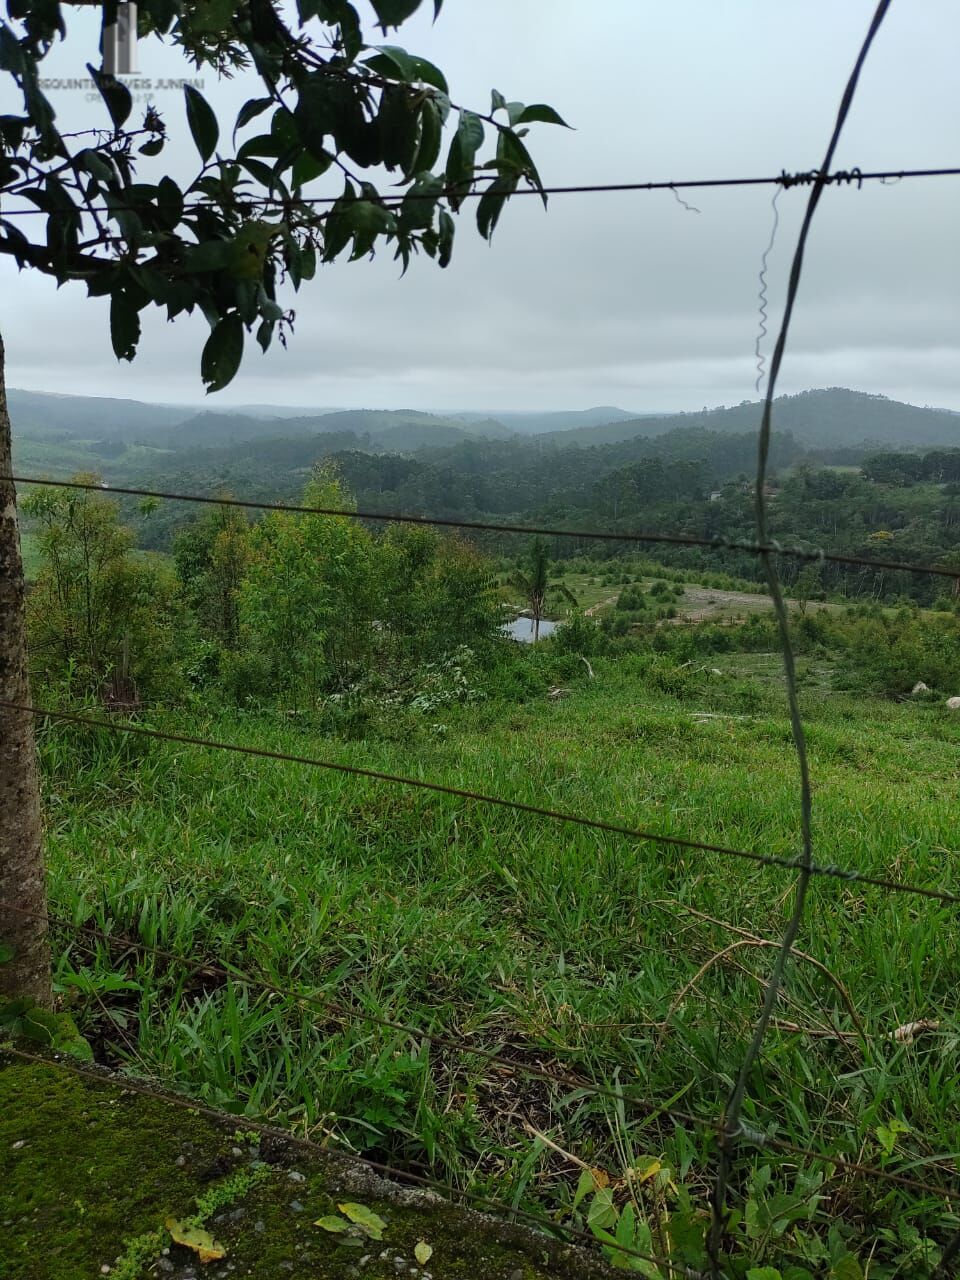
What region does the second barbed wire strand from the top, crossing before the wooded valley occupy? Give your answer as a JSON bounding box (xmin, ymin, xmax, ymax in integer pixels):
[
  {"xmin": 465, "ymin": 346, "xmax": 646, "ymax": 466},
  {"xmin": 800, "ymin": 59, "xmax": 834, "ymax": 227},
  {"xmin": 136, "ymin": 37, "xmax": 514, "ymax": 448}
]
[{"xmin": 9, "ymin": 475, "xmax": 960, "ymax": 581}]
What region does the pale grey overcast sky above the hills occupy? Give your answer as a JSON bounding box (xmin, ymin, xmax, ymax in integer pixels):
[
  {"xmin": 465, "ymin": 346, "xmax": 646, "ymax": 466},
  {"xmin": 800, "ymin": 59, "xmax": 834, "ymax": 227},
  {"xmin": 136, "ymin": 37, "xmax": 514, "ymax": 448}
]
[{"xmin": 0, "ymin": 0, "xmax": 960, "ymax": 412}]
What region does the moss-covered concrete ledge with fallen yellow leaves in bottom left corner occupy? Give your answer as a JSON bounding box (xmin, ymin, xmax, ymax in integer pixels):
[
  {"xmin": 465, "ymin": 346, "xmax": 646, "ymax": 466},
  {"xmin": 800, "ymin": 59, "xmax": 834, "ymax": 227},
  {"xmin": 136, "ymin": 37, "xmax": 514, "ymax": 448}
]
[{"xmin": 0, "ymin": 1047, "xmax": 613, "ymax": 1280}]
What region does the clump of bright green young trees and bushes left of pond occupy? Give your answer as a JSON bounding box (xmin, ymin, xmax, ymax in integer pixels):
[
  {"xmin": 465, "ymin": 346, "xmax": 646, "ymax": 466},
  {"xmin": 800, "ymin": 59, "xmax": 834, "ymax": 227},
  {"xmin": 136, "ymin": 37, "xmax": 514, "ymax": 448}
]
[{"xmin": 23, "ymin": 467, "xmax": 500, "ymax": 708}]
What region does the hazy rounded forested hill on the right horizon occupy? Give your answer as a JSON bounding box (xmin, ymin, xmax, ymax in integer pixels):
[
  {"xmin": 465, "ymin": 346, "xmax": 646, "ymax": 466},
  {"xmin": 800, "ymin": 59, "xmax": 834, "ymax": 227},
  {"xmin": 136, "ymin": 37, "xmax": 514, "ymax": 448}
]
[{"xmin": 541, "ymin": 387, "xmax": 960, "ymax": 448}]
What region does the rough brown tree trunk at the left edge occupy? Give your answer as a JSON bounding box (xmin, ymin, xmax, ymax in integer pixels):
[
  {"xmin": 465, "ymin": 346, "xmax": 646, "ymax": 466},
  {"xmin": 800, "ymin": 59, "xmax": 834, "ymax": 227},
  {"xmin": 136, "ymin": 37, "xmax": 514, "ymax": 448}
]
[{"xmin": 0, "ymin": 338, "xmax": 52, "ymax": 1007}]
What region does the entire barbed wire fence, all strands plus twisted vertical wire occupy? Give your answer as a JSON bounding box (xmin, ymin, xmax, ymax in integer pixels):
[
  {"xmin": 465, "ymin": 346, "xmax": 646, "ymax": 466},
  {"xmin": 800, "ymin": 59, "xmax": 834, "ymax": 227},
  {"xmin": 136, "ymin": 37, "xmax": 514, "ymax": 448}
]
[{"xmin": 0, "ymin": 0, "xmax": 960, "ymax": 1280}]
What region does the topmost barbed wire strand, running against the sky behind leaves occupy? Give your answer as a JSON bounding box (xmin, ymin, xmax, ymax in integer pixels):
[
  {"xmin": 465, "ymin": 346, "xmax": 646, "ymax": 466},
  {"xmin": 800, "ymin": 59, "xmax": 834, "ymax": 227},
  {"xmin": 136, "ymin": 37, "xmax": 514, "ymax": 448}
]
[{"xmin": 0, "ymin": 165, "xmax": 960, "ymax": 225}]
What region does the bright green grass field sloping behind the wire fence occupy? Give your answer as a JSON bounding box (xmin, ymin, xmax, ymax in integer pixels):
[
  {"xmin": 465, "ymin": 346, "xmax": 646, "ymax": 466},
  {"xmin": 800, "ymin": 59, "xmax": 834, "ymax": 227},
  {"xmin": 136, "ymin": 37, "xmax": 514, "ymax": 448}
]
[{"xmin": 33, "ymin": 654, "xmax": 960, "ymax": 1280}]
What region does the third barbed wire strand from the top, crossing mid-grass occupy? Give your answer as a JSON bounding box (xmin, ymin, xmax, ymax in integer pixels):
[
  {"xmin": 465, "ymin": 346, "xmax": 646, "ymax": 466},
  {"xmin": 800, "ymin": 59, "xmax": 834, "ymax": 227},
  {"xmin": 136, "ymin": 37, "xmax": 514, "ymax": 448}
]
[{"xmin": 0, "ymin": 698, "xmax": 960, "ymax": 905}]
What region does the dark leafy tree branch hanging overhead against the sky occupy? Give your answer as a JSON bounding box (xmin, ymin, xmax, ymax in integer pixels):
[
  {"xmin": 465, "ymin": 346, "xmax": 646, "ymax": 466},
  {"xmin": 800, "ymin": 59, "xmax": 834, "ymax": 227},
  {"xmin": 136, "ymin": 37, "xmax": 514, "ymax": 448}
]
[{"xmin": 0, "ymin": 0, "xmax": 564, "ymax": 392}]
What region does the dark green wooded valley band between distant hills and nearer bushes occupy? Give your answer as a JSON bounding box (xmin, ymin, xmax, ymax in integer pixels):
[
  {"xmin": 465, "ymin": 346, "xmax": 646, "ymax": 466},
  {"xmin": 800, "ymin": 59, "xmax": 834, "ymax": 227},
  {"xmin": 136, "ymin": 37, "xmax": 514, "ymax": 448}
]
[{"xmin": 47, "ymin": 428, "xmax": 960, "ymax": 605}]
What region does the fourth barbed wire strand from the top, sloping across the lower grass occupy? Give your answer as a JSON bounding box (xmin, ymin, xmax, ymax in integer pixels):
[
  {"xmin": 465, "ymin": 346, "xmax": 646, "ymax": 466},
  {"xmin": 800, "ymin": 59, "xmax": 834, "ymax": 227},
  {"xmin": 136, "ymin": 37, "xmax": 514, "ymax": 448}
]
[{"xmin": 0, "ymin": 902, "xmax": 960, "ymax": 1204}]
